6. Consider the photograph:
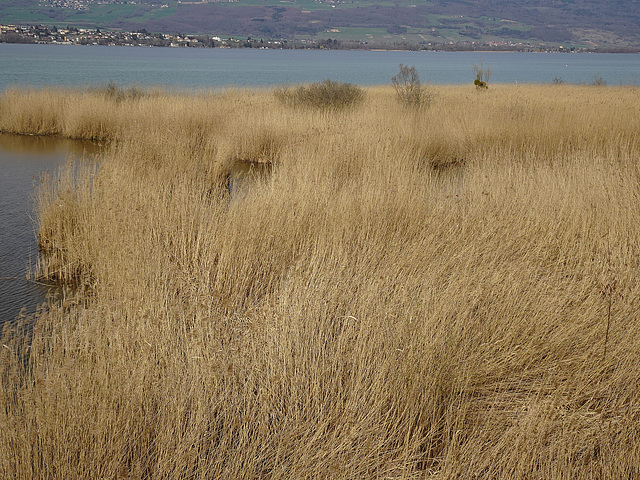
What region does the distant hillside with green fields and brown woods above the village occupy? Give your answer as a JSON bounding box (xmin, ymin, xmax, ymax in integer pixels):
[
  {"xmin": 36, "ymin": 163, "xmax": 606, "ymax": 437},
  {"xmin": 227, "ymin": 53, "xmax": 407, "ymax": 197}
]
[{"xmin": 0, "ymin": 0, "xmax": 640, "ymax": 47}]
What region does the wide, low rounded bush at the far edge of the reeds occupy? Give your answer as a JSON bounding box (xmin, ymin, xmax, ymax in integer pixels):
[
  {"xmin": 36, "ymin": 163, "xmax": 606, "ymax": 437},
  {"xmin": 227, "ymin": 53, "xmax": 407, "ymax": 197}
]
[{"xmin": 275, "ymin": 79, "xmax": 365, "ymax": 109}]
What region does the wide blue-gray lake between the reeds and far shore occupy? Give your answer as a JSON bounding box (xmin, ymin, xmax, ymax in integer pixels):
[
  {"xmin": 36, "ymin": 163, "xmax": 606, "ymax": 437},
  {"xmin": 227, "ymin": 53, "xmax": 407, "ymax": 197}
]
[{"xmin": 0, "ymin": 44, "xmax": 640, "ymax": 91}]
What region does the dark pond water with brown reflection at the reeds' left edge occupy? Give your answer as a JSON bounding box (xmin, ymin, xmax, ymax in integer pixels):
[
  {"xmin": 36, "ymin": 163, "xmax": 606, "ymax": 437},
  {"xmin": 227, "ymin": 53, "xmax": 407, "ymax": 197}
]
[{"xmin": 0, "ymin": 134, "xmax": 100, "ymax": 325}]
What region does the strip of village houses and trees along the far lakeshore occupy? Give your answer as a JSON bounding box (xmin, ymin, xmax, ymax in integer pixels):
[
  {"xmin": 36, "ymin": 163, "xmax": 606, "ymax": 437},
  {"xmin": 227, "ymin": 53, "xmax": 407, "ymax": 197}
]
[{"xmin": 0, "ymin": 24, "xmax": 638, "ymax": 53}]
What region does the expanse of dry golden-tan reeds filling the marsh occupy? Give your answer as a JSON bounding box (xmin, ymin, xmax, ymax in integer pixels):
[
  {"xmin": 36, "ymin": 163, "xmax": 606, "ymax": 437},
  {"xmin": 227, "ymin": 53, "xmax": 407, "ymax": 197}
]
[{"xmin": 0, "ymin": 85, "xmax": 640, "ymax": 479}]
